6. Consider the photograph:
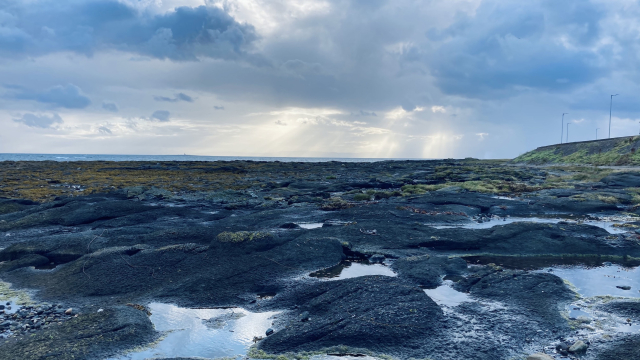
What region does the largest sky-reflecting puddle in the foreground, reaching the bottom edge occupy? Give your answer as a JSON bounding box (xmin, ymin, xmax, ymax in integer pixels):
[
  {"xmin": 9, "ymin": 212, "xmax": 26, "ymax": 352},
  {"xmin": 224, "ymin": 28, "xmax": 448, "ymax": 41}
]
[{"xmin": 111, "ymin": 303, "xmax": 278, "ymax": 360}]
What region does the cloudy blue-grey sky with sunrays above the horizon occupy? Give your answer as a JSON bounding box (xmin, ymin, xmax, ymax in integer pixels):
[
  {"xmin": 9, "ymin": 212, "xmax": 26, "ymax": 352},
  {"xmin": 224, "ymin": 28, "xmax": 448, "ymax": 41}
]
[{"xmin": 0, "ymin": 0, "xmax": 640, "ymax": 158}]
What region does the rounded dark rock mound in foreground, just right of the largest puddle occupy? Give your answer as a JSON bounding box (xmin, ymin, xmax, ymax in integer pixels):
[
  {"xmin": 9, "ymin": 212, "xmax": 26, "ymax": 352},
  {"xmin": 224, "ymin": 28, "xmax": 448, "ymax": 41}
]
[{"xmin": 260, "ymin": 276, "xmax": 443, "ymax": 355}]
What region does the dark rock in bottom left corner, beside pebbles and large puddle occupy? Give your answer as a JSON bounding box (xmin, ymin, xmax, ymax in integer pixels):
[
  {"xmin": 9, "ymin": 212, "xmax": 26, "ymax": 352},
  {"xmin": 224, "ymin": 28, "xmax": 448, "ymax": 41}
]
[{"xmin": 0, "ymin": 307, "xmax": 156, "ymax": 360}]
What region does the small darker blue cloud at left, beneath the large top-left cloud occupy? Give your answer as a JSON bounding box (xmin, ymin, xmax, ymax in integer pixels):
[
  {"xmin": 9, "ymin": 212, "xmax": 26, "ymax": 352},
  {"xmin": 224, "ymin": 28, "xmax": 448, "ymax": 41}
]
[{"xmin": 12, "ymin": 84, "xmax": 91, "ymax": 109}]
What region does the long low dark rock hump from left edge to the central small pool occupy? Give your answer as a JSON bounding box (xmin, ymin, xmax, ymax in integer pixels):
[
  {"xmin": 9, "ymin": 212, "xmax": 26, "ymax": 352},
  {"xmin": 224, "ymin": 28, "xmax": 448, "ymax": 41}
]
[{"xmin": 3, "ymin": 229, "xmax": 344, "ymax": 305}]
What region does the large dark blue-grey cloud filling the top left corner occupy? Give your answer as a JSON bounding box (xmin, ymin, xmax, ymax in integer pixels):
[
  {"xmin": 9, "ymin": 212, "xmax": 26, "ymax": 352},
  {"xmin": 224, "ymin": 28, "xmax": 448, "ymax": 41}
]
[{"xmin": 0, "ymin": 0, "xmax": 256, "ymax": 60}]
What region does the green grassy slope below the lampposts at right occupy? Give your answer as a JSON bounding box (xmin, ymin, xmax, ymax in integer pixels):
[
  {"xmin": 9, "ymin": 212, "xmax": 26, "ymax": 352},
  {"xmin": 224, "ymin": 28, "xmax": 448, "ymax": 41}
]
[{"xmin": 513, "ymin": 136, "xmax": 640, "ymax": 166}]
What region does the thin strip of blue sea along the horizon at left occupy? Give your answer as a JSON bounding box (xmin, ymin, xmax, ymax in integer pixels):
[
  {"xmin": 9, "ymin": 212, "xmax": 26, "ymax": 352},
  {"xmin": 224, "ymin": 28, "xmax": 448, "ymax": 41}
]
[{"xmin": 0, "ymin": 154, "xmax": 427, "ymax": 162}]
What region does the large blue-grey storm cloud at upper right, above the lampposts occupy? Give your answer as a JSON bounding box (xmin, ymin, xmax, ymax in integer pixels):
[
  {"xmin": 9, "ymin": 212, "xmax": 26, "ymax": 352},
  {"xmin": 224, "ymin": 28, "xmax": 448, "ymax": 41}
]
[{"xmin": 420, "ymin": 0, "xmax": 609, "ymax": 98}]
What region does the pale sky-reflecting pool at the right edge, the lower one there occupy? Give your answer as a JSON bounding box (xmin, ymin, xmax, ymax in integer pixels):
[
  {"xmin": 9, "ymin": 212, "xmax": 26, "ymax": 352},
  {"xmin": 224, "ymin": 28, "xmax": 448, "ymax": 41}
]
[{"xmin": 552, "ymin": 265, "xmax": 640, "ymax": 298}]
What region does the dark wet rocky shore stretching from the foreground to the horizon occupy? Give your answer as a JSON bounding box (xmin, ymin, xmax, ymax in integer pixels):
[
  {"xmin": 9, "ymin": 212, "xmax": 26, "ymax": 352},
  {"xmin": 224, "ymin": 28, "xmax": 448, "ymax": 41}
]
[{"xmin": 0, "ymin": 160, "xmax": 640, "ymax": 360}]
